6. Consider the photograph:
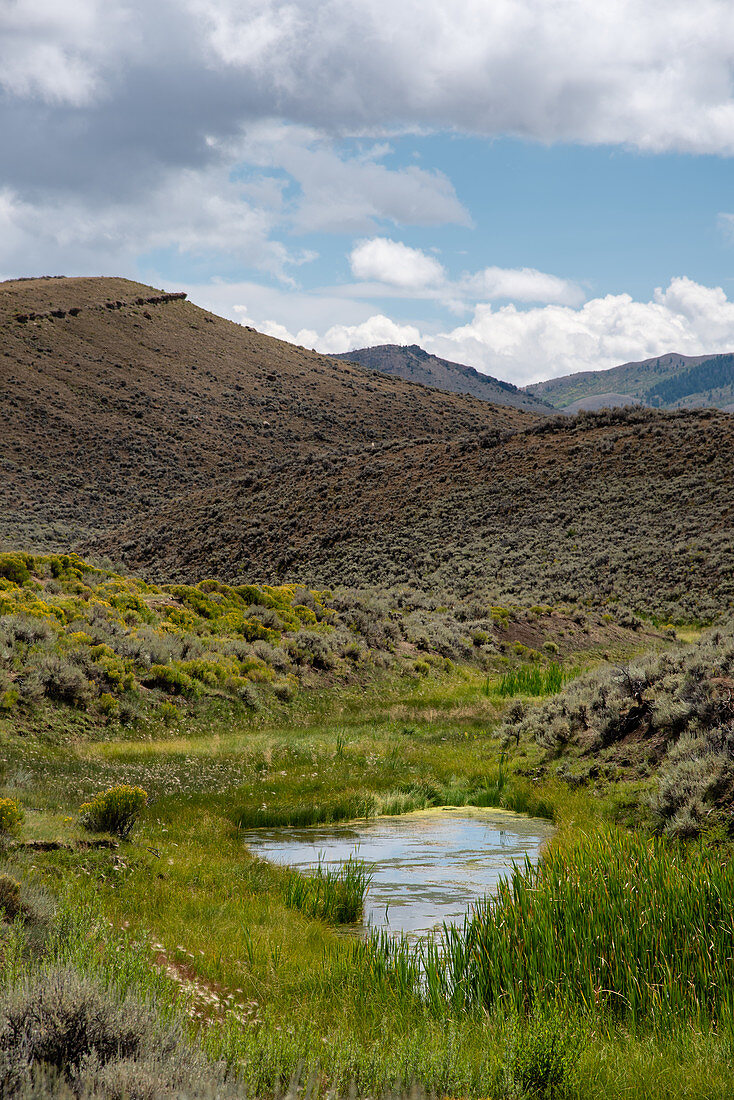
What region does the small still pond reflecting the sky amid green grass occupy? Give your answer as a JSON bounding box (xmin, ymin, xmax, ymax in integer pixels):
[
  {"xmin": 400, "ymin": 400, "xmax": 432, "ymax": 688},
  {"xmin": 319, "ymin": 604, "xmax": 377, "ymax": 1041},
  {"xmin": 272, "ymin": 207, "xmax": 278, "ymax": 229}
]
[{"xmin": 242, "ymin": 806, "xmax": 552, "ymax": 937}]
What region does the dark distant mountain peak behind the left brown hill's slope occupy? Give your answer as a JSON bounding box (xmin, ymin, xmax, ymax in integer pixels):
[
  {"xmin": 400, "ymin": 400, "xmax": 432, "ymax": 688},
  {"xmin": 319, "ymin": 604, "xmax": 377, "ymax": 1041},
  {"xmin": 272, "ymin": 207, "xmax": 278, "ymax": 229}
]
[{"xmin": 333, "ymin": 344, "xmax": 550, "ymax": 416}]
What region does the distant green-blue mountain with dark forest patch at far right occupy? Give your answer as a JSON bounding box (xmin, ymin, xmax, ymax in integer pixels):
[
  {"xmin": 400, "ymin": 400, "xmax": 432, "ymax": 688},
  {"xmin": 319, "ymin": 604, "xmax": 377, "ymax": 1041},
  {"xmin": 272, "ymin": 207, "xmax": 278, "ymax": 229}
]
[{"xmin": 525, "ymin": 352, "xmax": 734, "ymax": 413}]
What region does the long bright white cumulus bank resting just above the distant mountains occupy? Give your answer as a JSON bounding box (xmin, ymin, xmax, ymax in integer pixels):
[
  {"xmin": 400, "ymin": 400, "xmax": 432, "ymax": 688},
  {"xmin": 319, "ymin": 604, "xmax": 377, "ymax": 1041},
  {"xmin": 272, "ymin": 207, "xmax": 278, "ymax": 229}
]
[{"xmin": 211, "ymin": 276, "xmax": 734, "ymax": 385}]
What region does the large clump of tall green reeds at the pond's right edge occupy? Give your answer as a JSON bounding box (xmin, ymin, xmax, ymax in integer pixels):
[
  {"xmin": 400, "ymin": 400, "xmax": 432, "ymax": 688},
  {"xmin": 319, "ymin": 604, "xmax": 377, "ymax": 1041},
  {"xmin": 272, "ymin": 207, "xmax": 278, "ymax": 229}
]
[{"xmin": 372, "ymin": 829, "xmax": 734, "ymax": 1025}]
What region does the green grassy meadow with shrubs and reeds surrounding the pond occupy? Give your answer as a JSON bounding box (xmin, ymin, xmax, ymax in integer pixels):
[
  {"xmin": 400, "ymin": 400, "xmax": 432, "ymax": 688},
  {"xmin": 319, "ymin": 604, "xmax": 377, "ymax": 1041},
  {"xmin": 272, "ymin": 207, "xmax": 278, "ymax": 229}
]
[{"xmin": 0, "ymin": 558, "xmax": 734, "ymax": 1100}]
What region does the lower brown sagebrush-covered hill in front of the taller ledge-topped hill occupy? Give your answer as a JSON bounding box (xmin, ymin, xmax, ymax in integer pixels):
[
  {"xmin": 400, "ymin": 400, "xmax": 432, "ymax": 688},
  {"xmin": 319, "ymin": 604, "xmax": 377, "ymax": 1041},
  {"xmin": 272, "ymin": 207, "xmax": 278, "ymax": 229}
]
[{"xmin": 96, "ymin": 408, "xmax": 734, "ymax": 620}]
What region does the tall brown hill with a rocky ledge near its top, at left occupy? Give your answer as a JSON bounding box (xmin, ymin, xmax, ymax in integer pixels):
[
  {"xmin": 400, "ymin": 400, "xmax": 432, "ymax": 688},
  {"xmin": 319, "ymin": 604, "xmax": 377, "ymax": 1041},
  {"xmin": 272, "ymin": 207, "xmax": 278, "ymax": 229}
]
[{"xmin": 0, "ymin": 278, "xmax": 526, "ymax": 549}]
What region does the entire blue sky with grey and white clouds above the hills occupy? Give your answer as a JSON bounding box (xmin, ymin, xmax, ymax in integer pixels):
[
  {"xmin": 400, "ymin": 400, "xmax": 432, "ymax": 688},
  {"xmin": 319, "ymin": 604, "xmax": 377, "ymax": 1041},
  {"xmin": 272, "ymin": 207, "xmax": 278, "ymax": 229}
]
[{"xmin": 0, "ymin": 0, "xmax": 734, "ymax": 384}]
